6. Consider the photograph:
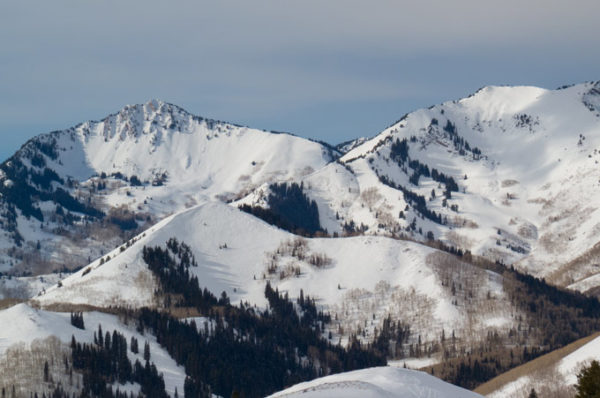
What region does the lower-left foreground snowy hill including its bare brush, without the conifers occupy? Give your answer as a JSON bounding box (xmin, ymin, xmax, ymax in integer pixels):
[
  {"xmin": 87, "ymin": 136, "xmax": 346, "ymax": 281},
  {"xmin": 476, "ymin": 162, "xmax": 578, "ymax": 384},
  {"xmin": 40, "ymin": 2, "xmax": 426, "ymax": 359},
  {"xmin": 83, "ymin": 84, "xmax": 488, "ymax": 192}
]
[{"xmin": 0, "ymin": 304, "xmax": 185, "ymax": 396}]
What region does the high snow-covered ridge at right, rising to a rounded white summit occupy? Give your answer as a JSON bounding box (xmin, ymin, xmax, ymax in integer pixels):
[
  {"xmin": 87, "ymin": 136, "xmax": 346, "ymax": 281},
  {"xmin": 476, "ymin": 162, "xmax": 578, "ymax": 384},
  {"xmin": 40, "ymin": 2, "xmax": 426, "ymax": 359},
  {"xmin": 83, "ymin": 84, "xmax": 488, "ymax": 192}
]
[{"xmin": 286, "ymin": 82, "xmax": 600, "ymax": 285}]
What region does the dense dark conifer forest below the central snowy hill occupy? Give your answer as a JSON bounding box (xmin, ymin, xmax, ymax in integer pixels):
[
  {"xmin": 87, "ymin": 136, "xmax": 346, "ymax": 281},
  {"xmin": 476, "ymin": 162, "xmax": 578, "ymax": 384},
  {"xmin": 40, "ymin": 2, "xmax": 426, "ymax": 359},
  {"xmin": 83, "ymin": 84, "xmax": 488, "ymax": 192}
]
[{"xmin": 137, "ymin": 240, "xmax": 386, "ymax": 397}]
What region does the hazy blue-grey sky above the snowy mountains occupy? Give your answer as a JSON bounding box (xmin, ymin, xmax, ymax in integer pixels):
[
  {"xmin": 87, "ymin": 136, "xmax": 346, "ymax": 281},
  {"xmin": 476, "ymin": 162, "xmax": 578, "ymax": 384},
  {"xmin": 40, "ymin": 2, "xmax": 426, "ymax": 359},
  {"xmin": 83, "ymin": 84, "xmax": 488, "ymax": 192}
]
[{"xmin": 0, "ymin": 0, "xmax": 600, "ymax": 160}]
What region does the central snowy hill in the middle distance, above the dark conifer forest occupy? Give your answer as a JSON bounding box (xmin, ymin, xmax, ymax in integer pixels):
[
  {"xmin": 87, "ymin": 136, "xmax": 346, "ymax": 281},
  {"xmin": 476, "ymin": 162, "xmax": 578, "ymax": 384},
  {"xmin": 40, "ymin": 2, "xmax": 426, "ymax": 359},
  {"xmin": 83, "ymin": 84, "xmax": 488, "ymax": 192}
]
[{"xmin": 34, "ymin": 202, "xmax": 518, "ymax": 352}]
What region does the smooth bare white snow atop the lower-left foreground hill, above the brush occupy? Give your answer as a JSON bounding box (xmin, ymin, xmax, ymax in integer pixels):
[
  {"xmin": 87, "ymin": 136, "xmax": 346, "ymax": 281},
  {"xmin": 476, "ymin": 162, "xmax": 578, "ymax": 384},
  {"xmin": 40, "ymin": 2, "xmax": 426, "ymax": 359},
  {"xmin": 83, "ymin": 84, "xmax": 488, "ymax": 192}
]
[{"xmin": 0, "ymin": 304, "xmax": 185, "ymax": 395}]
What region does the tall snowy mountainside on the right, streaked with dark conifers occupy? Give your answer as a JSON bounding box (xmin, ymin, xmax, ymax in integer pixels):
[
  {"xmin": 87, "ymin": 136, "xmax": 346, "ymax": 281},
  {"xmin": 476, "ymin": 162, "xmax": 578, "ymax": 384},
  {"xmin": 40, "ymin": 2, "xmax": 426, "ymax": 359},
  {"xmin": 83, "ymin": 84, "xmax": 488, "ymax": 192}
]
[{"xmin": 264, "ymin": 82, "xmax": 600, "ymax": 291}]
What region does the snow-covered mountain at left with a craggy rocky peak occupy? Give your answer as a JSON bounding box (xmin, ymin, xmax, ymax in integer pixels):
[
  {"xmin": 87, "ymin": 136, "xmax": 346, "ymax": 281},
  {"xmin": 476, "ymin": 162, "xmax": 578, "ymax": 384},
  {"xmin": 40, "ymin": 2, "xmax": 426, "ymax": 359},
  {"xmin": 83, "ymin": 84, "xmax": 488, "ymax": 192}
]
[{"xmin": 0, "ymin": 101, "xmax": 337, "ymax": 273}]
